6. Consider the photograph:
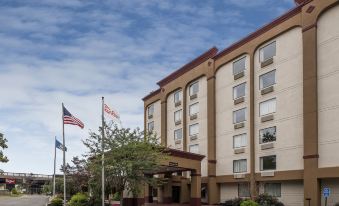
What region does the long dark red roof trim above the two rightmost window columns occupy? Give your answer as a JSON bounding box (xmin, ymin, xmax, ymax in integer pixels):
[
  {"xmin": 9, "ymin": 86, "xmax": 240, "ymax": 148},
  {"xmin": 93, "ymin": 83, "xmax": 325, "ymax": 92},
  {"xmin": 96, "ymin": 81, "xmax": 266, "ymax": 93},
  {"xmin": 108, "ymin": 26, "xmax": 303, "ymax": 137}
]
[{"xmin": 214, "ymin": 4, "xmax": 307, "ymax": 60}]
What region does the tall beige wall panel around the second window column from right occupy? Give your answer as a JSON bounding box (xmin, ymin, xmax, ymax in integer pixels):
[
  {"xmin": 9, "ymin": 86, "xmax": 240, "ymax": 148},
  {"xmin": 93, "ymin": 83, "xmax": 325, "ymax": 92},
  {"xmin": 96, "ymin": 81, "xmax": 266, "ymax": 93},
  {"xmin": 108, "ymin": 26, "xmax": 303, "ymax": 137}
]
[{"xmin": 216, "ymin": 55, "xmax": 250, "ymax": 176}]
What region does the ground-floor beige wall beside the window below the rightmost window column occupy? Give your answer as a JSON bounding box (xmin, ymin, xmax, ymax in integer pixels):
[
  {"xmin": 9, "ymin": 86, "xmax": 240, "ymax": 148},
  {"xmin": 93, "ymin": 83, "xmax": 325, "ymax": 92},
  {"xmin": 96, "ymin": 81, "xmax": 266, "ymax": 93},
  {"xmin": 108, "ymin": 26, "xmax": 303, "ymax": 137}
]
[{"xmin": 259, "ymin": 181, "xmax": 304, "ymax": 206}]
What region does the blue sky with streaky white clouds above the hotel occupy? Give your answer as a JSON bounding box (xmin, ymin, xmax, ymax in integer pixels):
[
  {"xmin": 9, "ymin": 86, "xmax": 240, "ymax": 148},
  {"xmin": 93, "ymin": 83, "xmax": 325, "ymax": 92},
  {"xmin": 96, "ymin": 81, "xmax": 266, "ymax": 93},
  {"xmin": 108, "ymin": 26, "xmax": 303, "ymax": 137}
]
[{"xmin": 0, "ymin": 0, "xmax": 295, "ymax": 174}]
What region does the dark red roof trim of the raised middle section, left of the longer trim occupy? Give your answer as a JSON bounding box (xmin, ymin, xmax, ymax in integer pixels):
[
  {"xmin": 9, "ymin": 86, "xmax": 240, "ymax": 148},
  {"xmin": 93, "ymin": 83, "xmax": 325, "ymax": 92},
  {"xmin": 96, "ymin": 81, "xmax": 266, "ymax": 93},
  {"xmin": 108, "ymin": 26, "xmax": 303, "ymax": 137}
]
[{"xmin": 157, "ymin": 47, "xmax": 218, "ymax": 87}]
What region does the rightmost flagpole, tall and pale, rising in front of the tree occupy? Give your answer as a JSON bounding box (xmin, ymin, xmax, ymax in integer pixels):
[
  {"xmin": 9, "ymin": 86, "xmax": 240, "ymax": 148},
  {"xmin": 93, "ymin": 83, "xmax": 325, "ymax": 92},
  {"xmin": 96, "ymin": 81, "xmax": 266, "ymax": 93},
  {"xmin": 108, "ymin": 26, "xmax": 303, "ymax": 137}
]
[{"xmin": 101, "ymin": 97, "xmax": 105, "ymax": 206}]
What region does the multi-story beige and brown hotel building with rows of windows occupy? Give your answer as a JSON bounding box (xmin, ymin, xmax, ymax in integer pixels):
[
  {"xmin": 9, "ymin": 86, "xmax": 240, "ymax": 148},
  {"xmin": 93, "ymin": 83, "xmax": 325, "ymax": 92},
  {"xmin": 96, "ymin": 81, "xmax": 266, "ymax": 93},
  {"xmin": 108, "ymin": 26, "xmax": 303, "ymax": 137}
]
[{"xmin": 143, "ymin": 0, "xmax": 339, "ymax": 206}]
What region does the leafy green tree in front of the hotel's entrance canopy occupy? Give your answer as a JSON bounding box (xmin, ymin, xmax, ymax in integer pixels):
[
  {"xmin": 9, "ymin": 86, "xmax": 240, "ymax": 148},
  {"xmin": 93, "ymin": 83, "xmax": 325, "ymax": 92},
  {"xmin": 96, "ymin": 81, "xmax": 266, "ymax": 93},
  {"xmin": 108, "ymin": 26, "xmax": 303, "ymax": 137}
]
[{"xmin": 84, "ymin": 125, "xmax": 167, "ymax": 203}]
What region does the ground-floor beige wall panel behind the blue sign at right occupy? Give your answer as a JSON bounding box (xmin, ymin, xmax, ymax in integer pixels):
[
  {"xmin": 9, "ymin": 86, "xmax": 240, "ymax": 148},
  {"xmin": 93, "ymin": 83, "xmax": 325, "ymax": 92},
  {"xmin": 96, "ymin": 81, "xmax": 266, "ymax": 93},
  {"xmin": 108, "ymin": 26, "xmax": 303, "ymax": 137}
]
[{"xmin": 321, "ymin": 179, "xmax": 339, "ymax": 206}]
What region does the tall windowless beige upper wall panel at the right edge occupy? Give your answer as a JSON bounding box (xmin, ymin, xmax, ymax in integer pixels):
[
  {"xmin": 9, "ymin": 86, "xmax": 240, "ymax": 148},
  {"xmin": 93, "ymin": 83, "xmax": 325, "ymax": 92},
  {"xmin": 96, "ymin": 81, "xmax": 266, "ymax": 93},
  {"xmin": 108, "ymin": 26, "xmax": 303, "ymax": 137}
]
[{"xmin": 317, "ymin": 6, "xmax": 339, "ymax": 167}]
